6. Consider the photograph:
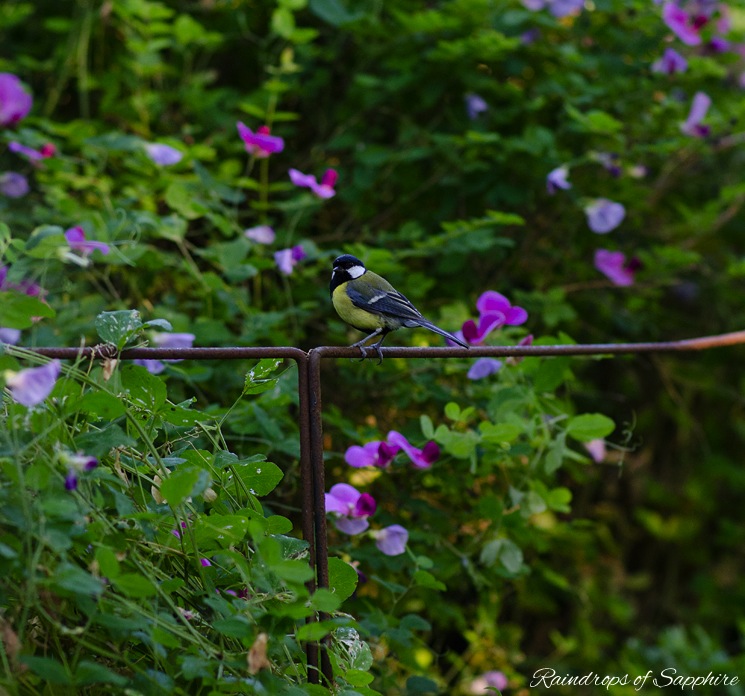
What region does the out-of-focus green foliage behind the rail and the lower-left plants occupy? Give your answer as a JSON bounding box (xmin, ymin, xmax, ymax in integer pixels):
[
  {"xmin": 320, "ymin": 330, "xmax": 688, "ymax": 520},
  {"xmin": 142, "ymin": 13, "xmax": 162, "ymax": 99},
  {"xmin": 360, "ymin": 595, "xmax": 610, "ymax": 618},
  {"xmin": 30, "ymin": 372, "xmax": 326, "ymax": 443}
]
[{"xmin": 0, "ymin": 0, "xmax": 745, "ymax": 694}]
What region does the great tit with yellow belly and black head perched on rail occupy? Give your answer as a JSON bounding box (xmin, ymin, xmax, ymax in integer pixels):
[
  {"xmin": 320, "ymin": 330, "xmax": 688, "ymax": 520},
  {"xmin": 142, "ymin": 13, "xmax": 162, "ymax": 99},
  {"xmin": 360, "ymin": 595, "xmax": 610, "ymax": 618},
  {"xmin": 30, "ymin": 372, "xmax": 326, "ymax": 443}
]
[{"xmin": 330, "ymin": 254, "xmax": 468, "ymax": 362}]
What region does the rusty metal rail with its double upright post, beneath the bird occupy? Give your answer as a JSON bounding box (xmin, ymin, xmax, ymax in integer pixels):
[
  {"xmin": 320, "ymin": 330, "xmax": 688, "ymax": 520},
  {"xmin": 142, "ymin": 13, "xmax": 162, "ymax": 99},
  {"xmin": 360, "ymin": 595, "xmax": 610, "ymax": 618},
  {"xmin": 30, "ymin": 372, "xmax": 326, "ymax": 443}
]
[{"xmin": 21, "ymin": 331, "xmax": 745, "ymax": 684}]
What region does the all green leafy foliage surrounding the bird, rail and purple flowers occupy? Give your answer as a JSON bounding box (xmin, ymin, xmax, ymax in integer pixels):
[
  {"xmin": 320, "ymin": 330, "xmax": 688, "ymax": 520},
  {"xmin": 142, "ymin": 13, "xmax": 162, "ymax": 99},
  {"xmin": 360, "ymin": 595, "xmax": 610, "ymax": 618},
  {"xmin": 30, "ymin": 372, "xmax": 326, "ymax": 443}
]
[{"xmin": 0, "ymin": 0, "xmax": 745, "ymax": 694}]
